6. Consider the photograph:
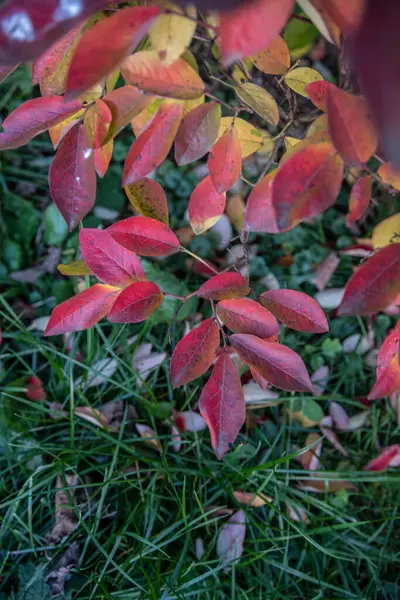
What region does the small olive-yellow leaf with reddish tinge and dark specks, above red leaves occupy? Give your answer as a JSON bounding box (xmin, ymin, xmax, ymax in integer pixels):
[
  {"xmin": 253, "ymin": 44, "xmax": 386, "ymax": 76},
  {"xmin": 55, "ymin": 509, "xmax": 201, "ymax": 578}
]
[{"xmin": 124, "ymin": 177, "xmax": 169, "ymax": 225}]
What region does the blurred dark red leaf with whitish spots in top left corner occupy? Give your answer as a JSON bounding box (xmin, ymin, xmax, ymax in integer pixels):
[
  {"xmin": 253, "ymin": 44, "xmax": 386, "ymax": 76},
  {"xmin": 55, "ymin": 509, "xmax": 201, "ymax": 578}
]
[{"xmin": 0, "ymin": 0, "xmax": 125, "ymax": 64}]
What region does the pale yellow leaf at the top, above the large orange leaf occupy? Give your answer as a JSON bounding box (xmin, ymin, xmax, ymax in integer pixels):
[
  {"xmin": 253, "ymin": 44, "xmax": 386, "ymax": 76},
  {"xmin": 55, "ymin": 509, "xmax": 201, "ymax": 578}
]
[{"xmin": 149, "ymin": 5, "xmax": 196, "ymax": 65}]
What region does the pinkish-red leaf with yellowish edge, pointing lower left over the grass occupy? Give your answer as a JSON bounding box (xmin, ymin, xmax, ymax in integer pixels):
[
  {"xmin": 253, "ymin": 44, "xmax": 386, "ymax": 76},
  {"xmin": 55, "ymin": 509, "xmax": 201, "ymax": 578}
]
[{"xmin": 44, "ymin": 283, "xmax": 121, "ymax": 335}]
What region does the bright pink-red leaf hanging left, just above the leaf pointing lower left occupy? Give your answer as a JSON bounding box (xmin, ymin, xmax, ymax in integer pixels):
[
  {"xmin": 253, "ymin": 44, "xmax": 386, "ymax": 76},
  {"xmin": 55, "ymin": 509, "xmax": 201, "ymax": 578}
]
[{"xmin": 79, "ymin": 229, "xmax": 146, "ymax": 287}]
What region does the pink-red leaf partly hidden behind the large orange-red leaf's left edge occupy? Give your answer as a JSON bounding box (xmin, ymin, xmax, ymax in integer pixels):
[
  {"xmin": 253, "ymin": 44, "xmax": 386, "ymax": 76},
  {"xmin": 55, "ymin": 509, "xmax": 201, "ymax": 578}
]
[{"xmin": 244, "ymin": 169, "xmax": 279, "ymax": 233}]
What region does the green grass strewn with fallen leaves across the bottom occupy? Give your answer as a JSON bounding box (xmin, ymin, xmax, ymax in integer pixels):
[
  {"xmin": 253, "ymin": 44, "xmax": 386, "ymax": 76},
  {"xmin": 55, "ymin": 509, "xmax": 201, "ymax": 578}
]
[{"xmin": 0, "ymin": 294, "xmax": 400, "ymax": 600}]
